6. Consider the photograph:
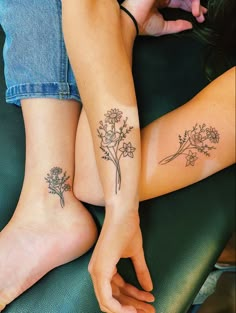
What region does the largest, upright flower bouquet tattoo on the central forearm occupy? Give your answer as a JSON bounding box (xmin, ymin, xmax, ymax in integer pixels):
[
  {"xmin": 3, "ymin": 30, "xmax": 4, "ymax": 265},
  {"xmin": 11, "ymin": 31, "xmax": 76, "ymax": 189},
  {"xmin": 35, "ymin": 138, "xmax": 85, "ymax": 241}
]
[{"xmin": 97, "ymin": 109, "xmax": 136, "ymax": 194}]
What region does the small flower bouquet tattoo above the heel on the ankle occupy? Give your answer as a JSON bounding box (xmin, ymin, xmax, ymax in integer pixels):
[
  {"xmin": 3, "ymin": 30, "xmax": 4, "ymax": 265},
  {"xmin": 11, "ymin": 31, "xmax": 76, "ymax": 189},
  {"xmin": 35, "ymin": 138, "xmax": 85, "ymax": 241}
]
[{"xmin": 45, "ymin": 167, "xmax": 71, "ymax": 208}]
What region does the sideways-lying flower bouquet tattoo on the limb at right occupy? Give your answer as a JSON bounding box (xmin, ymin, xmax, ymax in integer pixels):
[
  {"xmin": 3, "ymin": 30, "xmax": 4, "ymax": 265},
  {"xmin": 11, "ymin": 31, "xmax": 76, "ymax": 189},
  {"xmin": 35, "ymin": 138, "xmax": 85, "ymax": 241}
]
[{"xmin": 159, "ymin": 124, "xmax": 220, "ymax": 166}]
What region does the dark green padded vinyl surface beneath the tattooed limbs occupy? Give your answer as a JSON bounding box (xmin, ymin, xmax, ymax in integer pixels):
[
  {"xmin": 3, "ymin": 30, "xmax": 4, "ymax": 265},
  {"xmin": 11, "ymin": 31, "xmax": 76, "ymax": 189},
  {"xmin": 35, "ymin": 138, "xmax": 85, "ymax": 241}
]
[{"xmin": 0, "ymin": 24, "xmax": 235, "ymax": 313}]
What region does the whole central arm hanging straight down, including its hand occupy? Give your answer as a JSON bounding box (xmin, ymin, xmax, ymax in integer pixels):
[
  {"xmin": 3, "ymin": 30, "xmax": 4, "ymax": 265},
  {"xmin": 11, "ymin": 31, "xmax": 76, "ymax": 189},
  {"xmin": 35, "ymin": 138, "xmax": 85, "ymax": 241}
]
[{"xmin": 60, "ymin": 0, "xmax": 153, "ymax": 313}]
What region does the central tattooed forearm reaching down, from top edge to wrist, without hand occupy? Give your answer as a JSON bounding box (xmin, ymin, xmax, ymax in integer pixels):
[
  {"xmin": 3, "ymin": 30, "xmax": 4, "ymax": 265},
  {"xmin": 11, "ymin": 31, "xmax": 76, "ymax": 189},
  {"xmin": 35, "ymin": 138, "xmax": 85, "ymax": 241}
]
[{"xmin": 63, "ymin": 0, "xmax": 140, "ymax": 211}]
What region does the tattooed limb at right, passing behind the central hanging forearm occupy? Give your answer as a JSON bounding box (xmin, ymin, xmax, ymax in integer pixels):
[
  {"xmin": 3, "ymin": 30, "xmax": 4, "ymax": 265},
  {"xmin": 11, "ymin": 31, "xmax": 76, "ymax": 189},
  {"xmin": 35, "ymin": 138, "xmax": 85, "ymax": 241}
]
[{"xmin": 74, "ymin": 68, "xmax": 235, "ymax": 205}]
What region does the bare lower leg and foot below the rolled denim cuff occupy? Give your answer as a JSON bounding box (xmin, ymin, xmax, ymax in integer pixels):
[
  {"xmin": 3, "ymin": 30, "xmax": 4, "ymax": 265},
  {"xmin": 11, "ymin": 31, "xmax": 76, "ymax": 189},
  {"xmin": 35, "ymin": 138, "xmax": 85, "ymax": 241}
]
[{"xmin": 0, "ymin": 99, "xmax": 97, "ymax": 311}]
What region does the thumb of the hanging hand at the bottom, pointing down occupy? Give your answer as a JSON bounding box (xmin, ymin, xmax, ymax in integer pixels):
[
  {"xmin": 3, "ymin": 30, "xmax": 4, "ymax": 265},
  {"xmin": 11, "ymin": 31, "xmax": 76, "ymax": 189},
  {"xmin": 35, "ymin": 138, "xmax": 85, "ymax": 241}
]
[{"xmin": 131, "ymin": 250, "xmax": 153, "ymax": 291}]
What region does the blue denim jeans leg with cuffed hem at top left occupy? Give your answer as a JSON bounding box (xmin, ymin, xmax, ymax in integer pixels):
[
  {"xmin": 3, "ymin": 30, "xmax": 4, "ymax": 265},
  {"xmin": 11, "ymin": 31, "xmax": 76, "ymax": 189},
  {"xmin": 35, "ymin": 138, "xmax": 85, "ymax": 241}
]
[{"xmin": 0, "ymin": 0, "xmax": 81, "ymax": 105}]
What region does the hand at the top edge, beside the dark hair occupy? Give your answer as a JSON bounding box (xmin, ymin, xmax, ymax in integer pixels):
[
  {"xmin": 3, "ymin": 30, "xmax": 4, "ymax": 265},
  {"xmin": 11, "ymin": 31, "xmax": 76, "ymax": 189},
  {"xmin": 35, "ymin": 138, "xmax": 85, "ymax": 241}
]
[{"xmin": 122, "ymin": 0, "xmax": 207, "ymax": 36}]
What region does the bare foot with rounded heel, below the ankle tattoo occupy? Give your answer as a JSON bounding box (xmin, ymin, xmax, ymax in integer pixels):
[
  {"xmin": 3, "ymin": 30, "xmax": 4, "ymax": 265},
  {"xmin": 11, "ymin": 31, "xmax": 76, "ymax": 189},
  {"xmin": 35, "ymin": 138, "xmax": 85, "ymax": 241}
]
[{"xmin": 0, "ymin": 195, "xmax": 97, "ymax": 311}]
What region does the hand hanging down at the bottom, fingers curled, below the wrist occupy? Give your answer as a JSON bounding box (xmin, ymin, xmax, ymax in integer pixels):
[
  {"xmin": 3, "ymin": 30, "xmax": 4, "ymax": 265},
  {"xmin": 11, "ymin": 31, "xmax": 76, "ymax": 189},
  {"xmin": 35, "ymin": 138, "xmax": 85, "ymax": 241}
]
[{"xmin": 89, "ymin": 212, "xmax": 155, "ymax": 313}]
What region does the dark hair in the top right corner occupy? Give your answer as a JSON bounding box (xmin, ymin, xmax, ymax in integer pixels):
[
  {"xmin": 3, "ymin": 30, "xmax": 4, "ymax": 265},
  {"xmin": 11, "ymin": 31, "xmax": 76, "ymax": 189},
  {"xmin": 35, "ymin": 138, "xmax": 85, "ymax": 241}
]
[{"xmin": 193, "ymin": 0, "xmax": 236, "ymax": 80}]
